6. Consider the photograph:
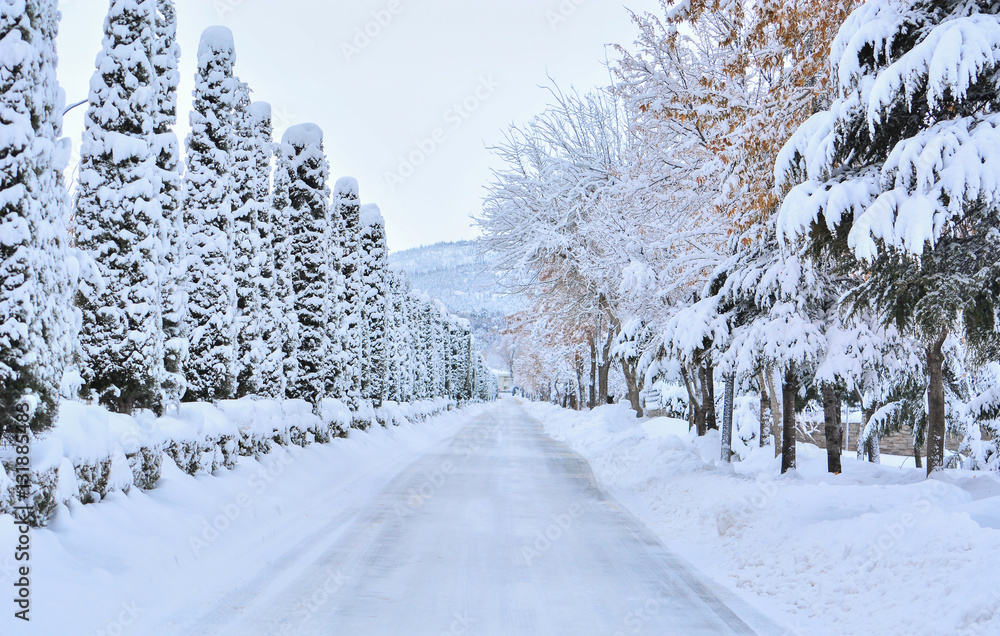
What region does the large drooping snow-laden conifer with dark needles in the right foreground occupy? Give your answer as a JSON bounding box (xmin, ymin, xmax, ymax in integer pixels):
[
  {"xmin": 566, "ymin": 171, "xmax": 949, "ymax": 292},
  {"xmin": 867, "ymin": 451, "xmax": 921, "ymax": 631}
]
[{"xmin": 775, "ymin": 0, "xmax": 1000, "ymax": 474}]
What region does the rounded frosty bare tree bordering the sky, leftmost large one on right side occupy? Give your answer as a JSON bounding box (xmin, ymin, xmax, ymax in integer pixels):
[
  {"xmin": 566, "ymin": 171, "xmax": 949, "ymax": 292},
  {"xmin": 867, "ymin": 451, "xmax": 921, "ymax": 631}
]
[{"xmin": 478, "ymin": 87, "xmax": 636, "ymax": 408}]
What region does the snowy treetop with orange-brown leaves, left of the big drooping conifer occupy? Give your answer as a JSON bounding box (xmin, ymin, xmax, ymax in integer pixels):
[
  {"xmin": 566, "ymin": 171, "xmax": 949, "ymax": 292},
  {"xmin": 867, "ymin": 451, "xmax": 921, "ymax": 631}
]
[{"xmin": 617, "ymin": 0, "xmax": 860, "ymax": 238}]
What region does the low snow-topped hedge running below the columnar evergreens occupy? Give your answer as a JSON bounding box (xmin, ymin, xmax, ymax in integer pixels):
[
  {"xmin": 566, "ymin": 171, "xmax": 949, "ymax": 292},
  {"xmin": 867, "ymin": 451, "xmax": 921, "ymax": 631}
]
[{"xmin": 0, "ymin": 398, "xmax": 456, "ymax": 525}]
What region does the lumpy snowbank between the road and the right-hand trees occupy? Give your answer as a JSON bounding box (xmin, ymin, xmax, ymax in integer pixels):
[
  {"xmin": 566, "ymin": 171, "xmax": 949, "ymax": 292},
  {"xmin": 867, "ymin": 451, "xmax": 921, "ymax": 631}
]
[{"xmin": 526, "ymin": 404, "xmax": 1000, "ymax": 635}]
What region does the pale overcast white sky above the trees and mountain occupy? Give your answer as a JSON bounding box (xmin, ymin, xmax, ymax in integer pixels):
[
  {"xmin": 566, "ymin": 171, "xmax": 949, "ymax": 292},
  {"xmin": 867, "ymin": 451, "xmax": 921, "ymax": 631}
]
[{"xmin": 59, "ymin": 0, "xmax": 659, "ymax": 250}]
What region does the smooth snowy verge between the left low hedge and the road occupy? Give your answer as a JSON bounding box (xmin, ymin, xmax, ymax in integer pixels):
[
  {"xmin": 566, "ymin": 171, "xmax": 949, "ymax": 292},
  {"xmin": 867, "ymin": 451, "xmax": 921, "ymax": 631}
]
[{"xmin": 0, "ymin": 407, "xmax": 481, "ymax": 635}]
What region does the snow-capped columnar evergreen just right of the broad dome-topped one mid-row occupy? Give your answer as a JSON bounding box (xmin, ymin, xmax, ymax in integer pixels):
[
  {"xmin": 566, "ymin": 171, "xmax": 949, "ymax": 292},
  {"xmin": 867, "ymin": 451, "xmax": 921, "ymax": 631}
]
[{"xmin": 330, "ymin": 177, "xmax": 363, "ymax": 409}]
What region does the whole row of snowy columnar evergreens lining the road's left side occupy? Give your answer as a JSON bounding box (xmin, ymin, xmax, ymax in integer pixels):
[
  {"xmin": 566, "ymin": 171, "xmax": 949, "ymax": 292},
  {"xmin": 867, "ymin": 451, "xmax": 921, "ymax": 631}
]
[{"xmin": 0, "ymin": 0, "xmax": 490, "ymax": 442}]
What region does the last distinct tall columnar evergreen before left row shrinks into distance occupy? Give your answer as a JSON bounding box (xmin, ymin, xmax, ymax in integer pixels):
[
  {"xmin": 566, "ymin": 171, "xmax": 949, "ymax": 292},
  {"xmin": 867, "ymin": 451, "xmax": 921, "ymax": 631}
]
[{"xmin": 360, "ymin": 203, "xmax": 389, "ymax": 408}]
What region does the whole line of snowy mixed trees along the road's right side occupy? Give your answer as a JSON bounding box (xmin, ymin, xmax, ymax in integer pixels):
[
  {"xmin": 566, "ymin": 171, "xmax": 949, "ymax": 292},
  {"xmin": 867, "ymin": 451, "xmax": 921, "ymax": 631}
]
[{"xmin": 480, "ymin": 0, "xmax": 1000, "ymax": 472}]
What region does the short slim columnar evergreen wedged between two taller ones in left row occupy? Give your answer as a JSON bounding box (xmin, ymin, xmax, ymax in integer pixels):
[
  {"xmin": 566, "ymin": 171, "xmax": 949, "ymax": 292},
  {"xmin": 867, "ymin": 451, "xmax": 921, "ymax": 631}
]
[{"xmin": 268, "ymin": 144, "xmax": 299, "ymax": 399}]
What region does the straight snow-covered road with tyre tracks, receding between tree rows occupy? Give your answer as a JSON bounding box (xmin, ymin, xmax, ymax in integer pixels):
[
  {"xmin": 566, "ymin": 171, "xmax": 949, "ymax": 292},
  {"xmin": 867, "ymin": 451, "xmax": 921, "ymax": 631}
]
[{"xmin": 152, "ymin": 399, "xmax": 776, "ymax": 636}]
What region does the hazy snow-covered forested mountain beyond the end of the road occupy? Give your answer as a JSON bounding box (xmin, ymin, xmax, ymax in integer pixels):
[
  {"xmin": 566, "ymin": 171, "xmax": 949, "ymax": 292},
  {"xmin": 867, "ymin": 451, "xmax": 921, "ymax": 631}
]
[{"xmin": 389, "ymin": 241, "xmax": 527, "ymax": 349}]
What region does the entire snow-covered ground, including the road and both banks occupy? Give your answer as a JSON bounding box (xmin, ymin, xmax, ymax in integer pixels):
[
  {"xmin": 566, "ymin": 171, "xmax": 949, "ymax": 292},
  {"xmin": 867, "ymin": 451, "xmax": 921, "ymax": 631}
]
[{"xmin": 9, "ymin": 398, "xmax": 1000, "ymax": 635}]
